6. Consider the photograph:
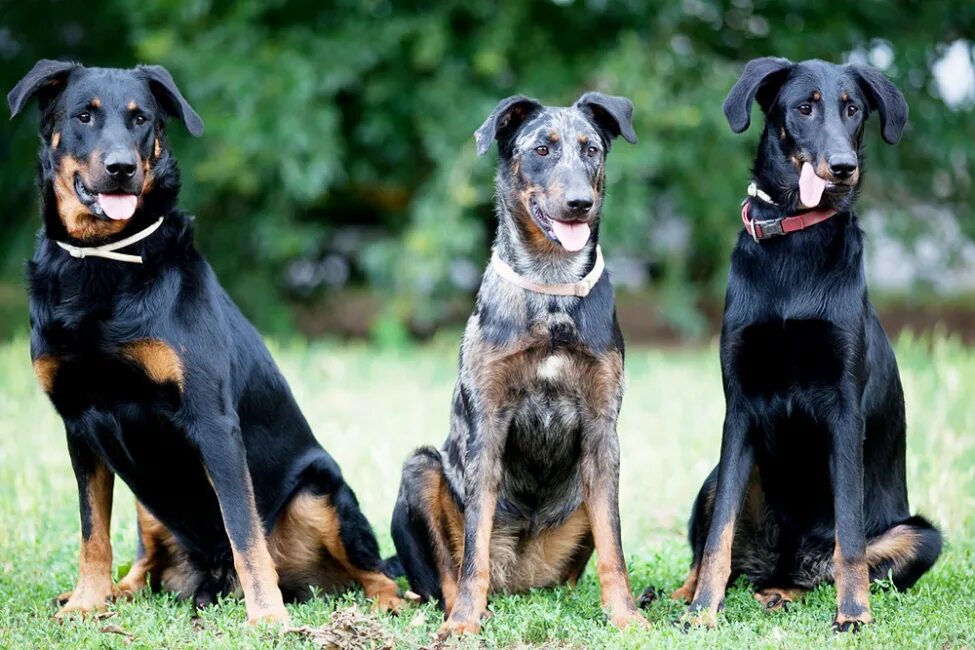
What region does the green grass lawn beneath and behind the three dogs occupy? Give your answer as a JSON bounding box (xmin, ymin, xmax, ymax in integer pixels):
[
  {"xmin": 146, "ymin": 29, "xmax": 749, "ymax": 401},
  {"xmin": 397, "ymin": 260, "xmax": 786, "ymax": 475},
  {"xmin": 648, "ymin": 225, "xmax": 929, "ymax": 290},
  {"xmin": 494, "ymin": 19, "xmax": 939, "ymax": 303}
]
[{"xmin": 0, "ymin": 337, "xmax": 975, "ymax": 648}]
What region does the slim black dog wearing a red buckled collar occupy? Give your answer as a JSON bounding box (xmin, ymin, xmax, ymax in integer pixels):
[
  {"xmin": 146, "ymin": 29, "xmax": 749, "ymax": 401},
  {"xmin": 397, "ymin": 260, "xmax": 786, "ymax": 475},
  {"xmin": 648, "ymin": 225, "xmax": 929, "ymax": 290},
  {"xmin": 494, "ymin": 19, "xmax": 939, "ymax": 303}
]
[{"xmin": 674, "ymin": 58, "xmax": 941, "ymax": 631}]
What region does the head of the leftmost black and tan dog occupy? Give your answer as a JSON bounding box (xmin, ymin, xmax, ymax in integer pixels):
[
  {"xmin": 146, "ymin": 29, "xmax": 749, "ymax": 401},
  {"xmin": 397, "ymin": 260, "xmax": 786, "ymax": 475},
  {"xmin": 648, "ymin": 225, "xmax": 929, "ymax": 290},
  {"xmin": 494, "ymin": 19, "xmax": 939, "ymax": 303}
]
[{"xmin": 7, "ymin": 60, "xmax": 203, "ymax": 240}]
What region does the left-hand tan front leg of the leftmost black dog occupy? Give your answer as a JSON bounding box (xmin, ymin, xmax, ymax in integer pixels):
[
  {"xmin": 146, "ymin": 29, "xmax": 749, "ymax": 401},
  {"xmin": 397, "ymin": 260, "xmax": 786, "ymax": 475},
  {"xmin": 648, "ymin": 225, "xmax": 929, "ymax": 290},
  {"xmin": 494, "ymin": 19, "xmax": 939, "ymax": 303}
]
[{"xmin": 55, "ymin": 426, "xmax": 115, "ymax": 619}]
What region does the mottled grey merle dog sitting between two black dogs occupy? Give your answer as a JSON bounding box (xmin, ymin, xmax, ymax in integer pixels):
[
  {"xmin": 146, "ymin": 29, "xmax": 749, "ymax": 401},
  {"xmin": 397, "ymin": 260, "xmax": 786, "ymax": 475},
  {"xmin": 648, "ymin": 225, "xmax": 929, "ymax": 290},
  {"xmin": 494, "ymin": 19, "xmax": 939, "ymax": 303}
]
[{"xmin": 393, "ymin": 93, "xmax": 646, "ymax": 635}]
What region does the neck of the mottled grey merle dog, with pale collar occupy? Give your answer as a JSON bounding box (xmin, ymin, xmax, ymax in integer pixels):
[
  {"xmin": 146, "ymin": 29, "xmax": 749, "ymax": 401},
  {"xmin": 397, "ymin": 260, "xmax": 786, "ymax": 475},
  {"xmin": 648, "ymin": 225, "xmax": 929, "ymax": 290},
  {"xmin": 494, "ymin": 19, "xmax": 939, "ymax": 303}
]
[{"xmin": 492, "ymin": 200, "xmax": 599, "ymax": 285}]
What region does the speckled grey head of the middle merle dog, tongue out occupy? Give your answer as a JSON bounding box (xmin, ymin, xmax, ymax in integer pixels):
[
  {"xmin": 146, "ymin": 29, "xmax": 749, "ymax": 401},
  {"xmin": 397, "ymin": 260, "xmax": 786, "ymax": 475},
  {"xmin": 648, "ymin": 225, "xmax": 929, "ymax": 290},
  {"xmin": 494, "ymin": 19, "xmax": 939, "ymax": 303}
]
[{"xmin": 474, "ymin": 92, "xmax": 636, "ymax": 251}]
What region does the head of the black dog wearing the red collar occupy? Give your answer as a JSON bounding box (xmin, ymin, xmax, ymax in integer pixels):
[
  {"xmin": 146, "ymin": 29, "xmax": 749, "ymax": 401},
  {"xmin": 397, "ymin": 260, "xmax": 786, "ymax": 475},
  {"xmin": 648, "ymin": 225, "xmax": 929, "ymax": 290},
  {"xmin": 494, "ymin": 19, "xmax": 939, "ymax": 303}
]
[{"xmin": 724, "ymin": 57, "xmax": 908, "ymax": 209}]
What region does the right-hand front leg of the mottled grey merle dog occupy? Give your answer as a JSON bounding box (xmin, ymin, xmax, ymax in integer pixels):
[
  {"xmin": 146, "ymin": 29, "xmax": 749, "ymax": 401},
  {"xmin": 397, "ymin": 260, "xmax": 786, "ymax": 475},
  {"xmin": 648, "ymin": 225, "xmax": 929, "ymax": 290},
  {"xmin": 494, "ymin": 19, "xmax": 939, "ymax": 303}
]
[{"xmin": 582, "ymin": 418, "xmax": 649, "ymax": 628}]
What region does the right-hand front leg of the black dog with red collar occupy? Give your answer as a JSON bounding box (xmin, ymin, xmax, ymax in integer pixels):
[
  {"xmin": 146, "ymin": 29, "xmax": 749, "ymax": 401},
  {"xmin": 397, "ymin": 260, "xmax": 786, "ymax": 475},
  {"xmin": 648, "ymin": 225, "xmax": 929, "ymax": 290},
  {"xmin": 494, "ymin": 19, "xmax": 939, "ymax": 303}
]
[{"xmin": 829, "ymin": 409, "xmax": 873, "ymax": 632}]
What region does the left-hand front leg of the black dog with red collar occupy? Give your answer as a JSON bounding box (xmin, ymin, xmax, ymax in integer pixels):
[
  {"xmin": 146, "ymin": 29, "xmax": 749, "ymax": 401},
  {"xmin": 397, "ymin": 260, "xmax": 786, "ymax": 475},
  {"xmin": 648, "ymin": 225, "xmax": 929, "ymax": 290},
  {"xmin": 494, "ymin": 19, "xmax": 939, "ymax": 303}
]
[{"xmin": 684, "ymin": 408, "xmax": 755, "ymax": 627}]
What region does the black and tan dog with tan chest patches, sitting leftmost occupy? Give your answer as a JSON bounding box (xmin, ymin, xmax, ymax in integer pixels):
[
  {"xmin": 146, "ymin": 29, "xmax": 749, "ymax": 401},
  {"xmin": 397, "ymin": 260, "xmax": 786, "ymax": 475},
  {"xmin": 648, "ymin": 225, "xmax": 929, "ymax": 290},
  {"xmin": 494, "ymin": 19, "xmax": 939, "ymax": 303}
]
[{"xmin": 7, "ymin": 61, "xmax": 400, "ymax": 622}]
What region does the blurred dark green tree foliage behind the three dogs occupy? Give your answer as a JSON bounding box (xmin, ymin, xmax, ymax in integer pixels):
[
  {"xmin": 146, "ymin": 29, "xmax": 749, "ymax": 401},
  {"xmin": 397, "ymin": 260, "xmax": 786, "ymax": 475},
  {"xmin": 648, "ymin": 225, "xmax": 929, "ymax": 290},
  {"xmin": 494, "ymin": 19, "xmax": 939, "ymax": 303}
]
[{"xmin": 0, "ymin": 0, "xmax": 975, "ymax": 341}]
